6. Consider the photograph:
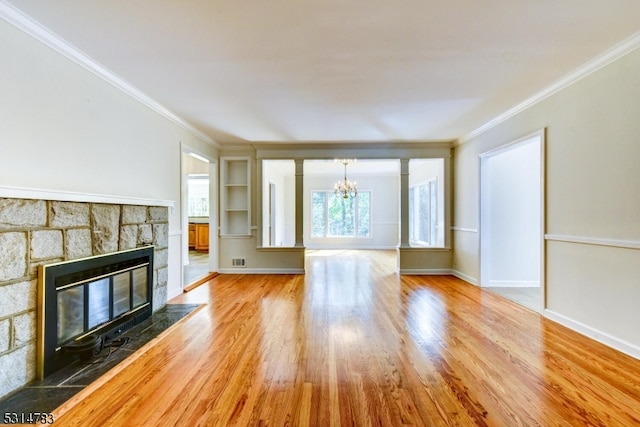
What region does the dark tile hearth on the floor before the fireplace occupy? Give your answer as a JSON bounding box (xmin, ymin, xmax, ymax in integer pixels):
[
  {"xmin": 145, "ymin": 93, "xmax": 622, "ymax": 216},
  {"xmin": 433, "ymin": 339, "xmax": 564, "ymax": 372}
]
[{"xmin": 0, "ymin": 304, "xmax": 200, "ymax": 423}]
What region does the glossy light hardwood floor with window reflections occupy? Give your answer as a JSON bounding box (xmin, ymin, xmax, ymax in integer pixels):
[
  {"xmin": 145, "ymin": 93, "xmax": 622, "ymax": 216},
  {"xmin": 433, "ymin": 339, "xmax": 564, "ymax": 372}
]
[{"xmin": 56, "ymin": 251, "xmax": 640, "ymax": 426}]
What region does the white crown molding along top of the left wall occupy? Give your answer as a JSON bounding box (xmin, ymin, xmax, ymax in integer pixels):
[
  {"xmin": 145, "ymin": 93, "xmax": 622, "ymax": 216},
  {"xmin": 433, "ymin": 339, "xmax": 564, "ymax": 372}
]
[{"xmin": 0, "ymin": 0, "xmax": 219, "ymax": 148}]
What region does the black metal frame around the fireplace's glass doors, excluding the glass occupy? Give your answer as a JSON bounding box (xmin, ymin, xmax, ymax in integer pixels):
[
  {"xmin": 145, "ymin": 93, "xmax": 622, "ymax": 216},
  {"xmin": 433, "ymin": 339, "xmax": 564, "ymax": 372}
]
[{"xmin": 36, "ymin": 246, "xmax": 154, "ymax": 380}]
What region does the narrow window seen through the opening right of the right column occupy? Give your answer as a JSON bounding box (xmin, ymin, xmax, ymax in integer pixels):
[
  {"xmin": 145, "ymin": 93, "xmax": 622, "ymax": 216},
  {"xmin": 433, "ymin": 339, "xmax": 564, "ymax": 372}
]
[{"xmin": 409, "ymin": 179, "xmax": 438, "ymax": 246}]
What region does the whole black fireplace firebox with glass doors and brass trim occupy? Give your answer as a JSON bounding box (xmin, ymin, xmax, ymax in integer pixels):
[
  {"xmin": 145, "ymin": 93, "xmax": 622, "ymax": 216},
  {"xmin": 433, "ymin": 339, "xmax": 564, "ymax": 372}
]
[{"xmin": 37, "ymin": 246, "xmax": 154, "ymax": 379}]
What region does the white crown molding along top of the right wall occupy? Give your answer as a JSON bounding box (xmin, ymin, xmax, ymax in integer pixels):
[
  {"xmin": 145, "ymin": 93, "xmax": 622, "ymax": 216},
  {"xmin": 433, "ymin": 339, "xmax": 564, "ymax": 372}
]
[{"xmin": 455, "ymin": 32, "xmax": 640, "ymax": 146}]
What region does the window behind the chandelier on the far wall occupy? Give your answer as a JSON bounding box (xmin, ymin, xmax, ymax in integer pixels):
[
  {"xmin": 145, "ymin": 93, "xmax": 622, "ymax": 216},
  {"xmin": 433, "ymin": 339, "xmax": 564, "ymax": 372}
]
[{"xmin": 311, "ymin": 191, "xmax": 371, "ymax": 238}]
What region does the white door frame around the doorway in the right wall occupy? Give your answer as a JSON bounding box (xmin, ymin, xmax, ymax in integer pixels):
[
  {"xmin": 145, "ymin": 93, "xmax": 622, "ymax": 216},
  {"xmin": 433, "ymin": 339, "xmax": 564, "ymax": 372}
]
[{"xmin": 478, "ymin": 129, "xmax": 546, "ymax": 313}]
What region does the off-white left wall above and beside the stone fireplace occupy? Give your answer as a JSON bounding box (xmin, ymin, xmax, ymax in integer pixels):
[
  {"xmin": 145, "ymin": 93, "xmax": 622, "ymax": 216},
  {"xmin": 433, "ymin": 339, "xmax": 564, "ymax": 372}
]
[{"xmin": 0, "ymin": 20, "xmax": 216, "ymax": 297}]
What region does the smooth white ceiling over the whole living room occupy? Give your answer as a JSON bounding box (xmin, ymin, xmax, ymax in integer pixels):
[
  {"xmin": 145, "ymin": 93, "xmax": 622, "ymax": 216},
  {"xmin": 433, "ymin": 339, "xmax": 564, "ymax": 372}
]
[{"xmin": 5, "ymin": 0, "xmax": 640, "ymax": 145}]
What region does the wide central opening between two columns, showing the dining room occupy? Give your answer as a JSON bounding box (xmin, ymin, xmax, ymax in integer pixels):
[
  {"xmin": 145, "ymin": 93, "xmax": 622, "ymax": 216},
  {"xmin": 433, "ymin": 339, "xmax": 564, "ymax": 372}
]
[{"xmin": 302, "ymin": 159, "xmax": 400, "ymax": 250}]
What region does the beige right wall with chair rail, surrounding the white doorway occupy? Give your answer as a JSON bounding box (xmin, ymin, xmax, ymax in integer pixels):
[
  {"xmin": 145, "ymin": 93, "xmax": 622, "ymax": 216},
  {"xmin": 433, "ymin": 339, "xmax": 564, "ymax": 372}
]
[{"xmin": 453, "ymin": 44, "xmax": 640, "ymax": 357}]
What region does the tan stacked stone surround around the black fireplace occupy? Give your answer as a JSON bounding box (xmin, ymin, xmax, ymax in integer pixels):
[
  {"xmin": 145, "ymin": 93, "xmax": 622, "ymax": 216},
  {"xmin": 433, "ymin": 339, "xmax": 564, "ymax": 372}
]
[{"xmin": 0, "ymin": 198, "xmax": 169, "ymax": 397}]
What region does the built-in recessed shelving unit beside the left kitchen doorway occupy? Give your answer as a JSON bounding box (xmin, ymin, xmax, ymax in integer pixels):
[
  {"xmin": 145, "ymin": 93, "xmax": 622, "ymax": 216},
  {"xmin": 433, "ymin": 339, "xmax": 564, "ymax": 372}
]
[{"xmin": 220, "ymin": 157, "xmax": 251, "ymax": 237}]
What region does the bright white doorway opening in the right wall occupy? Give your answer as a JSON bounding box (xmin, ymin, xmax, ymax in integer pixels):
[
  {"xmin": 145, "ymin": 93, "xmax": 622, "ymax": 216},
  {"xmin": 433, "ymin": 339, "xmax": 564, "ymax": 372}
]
[{"xmin": 480, "ymin": 131, "xmax": 544, "ymax": 312}]
